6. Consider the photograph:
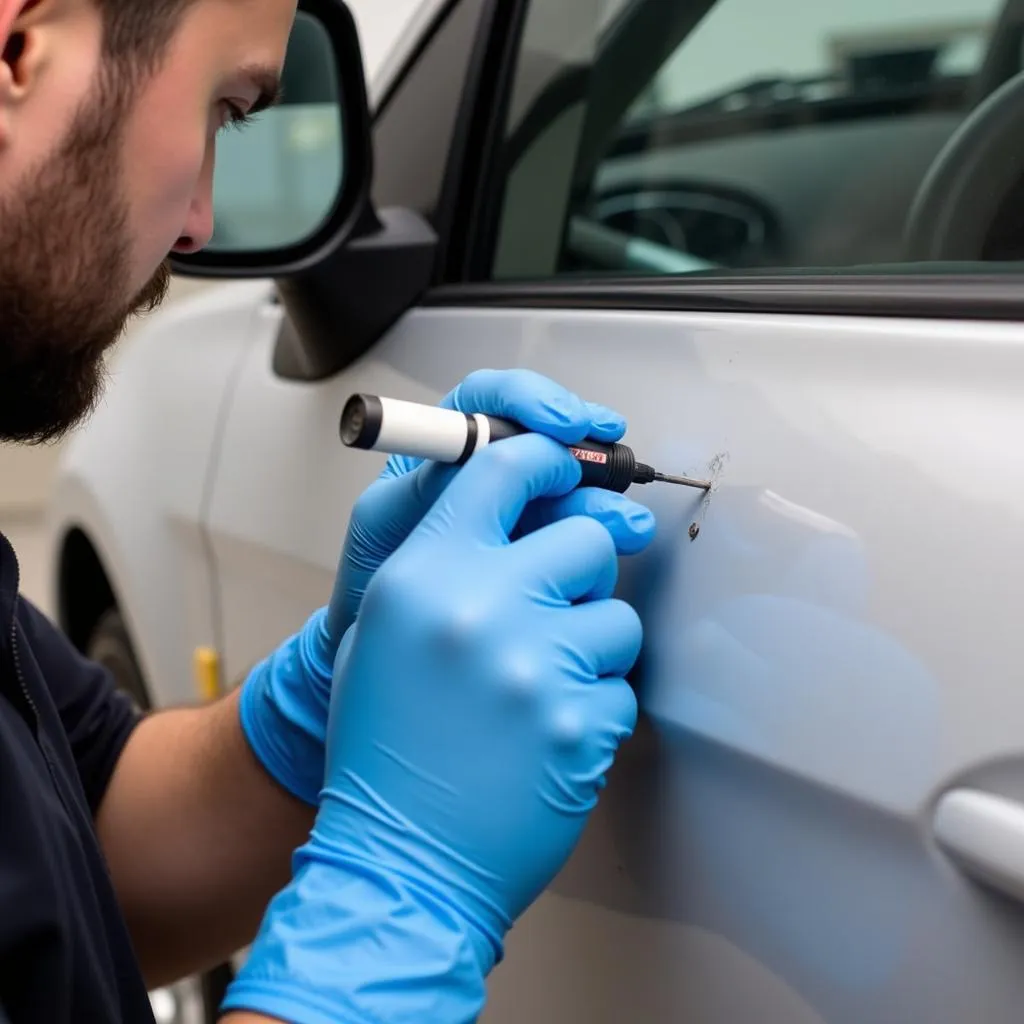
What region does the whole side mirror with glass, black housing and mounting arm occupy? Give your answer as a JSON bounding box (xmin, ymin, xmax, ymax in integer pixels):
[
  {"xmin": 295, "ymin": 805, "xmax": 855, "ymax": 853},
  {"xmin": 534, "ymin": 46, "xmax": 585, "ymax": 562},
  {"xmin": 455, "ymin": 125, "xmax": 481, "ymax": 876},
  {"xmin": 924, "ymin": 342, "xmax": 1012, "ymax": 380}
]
[{"xmin": 171, "ymin": 0, "xmax": 437, "ymax": 380}]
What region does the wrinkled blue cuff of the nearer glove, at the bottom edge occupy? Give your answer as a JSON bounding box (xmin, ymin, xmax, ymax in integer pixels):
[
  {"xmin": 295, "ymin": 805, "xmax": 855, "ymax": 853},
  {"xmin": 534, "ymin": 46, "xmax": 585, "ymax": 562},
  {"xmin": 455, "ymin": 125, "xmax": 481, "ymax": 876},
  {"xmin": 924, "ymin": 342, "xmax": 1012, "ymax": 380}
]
[{"xmin": 221, "ymin": 838, "xmax": 495, "ymax": 1024}]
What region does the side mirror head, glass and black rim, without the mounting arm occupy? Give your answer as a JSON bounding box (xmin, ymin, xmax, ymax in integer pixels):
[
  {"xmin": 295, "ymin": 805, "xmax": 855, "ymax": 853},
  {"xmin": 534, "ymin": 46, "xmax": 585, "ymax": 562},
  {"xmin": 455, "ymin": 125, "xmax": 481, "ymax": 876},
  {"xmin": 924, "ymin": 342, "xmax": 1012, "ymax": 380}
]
[{"xmin": 172, "ymin": 0, "xmax": 372, "ymax": 278}]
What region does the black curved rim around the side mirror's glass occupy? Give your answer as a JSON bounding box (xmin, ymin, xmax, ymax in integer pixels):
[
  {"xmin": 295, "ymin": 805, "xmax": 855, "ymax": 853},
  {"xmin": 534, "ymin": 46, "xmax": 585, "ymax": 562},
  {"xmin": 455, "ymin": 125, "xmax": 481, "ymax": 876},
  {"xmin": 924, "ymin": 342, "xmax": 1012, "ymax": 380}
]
[{"xmin": 170, "ymin": 0, "xmax": 380, "ymax": 279}]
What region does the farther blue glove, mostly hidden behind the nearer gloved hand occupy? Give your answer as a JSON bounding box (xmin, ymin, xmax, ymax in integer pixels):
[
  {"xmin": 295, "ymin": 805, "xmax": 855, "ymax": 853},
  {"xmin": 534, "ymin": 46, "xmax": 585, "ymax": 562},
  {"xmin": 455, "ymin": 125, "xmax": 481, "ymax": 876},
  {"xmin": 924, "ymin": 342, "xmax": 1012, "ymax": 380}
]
[{"xmin": 241, "ymin": 370, "xmax": 653, "ymax": 805}]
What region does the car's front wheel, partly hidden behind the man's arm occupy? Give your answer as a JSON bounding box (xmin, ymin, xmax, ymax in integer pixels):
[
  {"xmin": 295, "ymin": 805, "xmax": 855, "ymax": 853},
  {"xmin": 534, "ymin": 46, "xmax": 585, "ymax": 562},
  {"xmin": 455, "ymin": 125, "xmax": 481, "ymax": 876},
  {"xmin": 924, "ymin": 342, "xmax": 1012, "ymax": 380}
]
[{"xmin": 85, "ymin": 608, "xmax": 234, "ymax": 1024}]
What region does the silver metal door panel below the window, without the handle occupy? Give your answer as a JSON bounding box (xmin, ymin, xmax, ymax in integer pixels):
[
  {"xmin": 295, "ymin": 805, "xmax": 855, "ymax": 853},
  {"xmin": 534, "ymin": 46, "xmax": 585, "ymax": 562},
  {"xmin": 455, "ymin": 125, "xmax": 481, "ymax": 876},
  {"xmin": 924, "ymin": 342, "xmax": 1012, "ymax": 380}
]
[{"xmin": 209, "ymin": 299, "xmax": 1024, "ymax": 1024}]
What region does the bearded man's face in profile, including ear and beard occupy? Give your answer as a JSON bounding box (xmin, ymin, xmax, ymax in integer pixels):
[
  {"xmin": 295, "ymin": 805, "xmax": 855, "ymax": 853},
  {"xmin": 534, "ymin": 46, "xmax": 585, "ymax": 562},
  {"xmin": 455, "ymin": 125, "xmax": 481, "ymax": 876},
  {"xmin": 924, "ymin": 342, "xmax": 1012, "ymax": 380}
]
[{"xmin": 0, "ymin": 0, "xmax": 295, "ymax": 441}]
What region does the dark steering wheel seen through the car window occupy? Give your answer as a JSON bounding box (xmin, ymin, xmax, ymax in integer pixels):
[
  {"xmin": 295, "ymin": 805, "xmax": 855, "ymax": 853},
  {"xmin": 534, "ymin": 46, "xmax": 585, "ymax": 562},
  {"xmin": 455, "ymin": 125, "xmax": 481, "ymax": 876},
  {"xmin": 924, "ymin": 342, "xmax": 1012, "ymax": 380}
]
[{"xmin": 904, "ymin": 72, "xmax": 1024, "ymax": 262}]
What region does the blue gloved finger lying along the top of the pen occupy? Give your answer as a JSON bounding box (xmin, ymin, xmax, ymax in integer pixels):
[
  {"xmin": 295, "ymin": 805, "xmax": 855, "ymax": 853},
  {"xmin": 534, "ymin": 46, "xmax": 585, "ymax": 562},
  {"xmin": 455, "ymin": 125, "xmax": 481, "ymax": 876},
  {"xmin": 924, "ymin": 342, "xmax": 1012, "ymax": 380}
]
[{"xmin": 441, "ymin": 370, "xmax": 626, "ymax": 442}]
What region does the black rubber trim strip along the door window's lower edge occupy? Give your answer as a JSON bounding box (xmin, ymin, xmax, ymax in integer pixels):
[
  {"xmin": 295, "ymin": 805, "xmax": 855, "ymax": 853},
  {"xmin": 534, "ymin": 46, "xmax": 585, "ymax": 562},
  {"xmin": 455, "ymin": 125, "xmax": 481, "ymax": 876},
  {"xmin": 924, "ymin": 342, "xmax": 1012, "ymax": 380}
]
[{"xmin": 420, "ymin": 270, "xmax": 1024, "ymax": 322}]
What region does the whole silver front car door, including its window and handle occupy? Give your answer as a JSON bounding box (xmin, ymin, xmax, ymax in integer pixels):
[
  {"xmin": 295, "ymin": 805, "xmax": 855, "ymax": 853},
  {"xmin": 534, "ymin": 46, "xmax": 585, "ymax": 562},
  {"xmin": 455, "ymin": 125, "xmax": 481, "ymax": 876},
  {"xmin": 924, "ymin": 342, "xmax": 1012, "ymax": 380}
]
[{"xmin": 180, "ymin": 0, "xmax": 1024, "ymax": 1024}]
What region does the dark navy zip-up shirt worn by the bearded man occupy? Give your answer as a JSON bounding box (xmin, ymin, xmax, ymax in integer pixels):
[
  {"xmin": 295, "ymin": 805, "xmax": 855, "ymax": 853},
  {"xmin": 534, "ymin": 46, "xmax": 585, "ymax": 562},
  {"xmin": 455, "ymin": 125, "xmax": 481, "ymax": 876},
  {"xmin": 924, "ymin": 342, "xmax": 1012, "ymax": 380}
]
[{"xmin": 0, "ymin": 536, "xmax": 153, "ymax": 1024}]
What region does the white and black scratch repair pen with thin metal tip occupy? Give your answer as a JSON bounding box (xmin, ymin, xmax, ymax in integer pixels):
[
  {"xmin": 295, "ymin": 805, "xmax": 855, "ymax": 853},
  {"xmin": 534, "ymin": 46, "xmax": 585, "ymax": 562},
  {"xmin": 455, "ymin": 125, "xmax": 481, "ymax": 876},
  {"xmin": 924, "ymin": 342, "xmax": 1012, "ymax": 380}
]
[{"xmin": 341, "ymin": 394, "xmax": 711, "ymax": 494}]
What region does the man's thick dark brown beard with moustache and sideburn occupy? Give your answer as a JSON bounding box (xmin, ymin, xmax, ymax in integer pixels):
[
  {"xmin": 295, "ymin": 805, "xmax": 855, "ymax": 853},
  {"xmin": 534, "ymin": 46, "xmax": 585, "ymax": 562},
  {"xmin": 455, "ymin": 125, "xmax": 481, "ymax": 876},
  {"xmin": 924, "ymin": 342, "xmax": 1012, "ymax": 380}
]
[{"xmin": 0, "ymin": 72, "xmax": 171, "ymax": 444}]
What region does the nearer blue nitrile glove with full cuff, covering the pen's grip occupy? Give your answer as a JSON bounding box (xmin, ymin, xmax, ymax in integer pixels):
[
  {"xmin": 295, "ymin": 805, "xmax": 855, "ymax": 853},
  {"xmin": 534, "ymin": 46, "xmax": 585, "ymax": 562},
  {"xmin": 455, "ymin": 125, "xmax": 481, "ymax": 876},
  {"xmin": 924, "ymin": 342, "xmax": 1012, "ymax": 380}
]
[{"xmin": 224, "ymin": 434, "xmax": 652, "ymax": 1024}]
